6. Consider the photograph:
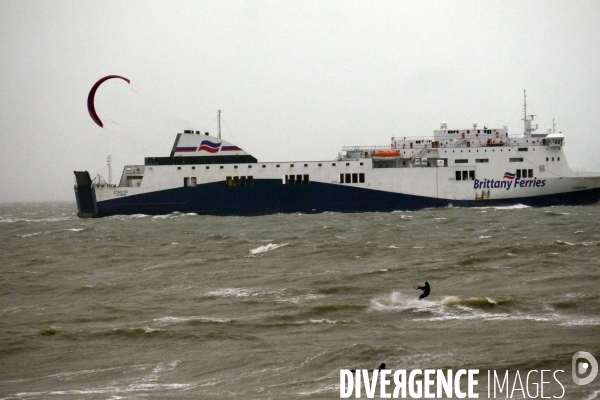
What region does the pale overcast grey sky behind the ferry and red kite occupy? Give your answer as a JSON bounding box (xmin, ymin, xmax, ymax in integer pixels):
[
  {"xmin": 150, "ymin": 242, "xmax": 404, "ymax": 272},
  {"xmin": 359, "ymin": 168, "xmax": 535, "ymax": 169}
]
[{"xmin": 0, "ymin": 0, "xmax": 600, "ymax": 202}]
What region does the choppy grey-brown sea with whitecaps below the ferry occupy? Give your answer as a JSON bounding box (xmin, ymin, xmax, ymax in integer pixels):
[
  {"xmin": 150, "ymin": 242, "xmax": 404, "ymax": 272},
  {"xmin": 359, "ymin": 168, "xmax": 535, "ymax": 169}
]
[{"xmin": 0, "ymin": 203, "xmax": 600, "ymax": 399}]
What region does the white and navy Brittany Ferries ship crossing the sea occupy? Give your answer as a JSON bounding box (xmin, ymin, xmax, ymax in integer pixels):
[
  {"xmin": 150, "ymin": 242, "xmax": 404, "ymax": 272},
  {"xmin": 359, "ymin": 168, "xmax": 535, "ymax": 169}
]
[{"xmin": 75, "ymin": 96, "xmax": 600, "ymax": 218}]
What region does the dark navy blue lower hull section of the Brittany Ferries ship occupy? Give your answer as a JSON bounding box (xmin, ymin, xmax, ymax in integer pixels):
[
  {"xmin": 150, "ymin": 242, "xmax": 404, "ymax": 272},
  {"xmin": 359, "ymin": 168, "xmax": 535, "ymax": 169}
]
[{"xmin": 76, "ymin": 179, "xmax": 600, "ymax": 217}]
